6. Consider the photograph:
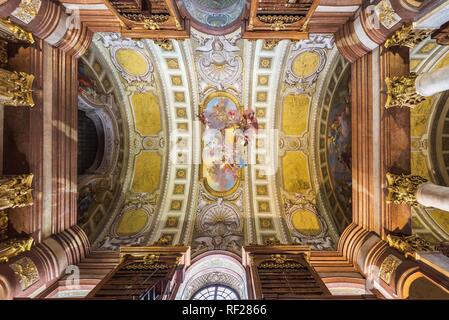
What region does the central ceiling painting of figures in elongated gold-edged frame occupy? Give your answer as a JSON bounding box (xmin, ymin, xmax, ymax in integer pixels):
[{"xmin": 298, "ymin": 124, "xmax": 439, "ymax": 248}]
[{"xmin": 198, "ymin": 91, "xmax": 258, "ymax": 196}]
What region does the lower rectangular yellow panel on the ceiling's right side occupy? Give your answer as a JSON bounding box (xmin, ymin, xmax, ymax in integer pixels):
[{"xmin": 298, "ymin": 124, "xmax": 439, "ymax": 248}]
[{"xmin": 282, "ymin": 151, "xmax": 310, "ymax": 193}]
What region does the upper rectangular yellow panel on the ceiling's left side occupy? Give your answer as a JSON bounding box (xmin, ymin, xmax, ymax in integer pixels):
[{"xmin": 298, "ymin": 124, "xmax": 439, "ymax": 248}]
[{"xmin": 131, "ymin": 92, "xmax": 161, "ymax": 136}]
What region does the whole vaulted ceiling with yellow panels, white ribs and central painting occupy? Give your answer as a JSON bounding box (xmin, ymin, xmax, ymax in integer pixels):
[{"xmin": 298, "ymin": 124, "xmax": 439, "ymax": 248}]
[{"xmin": 79, "ymin": 25, "xmax": 351, "ymax": 255}]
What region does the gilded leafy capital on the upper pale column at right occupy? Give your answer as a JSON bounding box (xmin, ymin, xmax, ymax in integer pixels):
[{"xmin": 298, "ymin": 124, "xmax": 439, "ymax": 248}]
[{"xmin": 385, "ymin": 73, "xmax": 425, "ymax": 109}]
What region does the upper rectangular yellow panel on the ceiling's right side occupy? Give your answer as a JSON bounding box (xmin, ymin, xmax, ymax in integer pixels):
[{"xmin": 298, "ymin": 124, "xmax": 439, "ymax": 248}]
[{"xmin": 282, "ymin": 94, "xmax": 310, "ymax": 135}]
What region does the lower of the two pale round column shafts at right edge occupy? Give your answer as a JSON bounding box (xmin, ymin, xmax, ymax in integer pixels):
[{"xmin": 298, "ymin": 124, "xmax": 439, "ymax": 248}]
[{"xmin": 416, "ymin": 182, "xmax": 449, "ymax": 211}]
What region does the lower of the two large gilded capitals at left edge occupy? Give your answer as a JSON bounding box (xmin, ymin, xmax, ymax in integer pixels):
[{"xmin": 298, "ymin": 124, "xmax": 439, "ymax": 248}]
[{"xmin": 0, "ymin": 174, "xmax": 33, "ymax": 210}]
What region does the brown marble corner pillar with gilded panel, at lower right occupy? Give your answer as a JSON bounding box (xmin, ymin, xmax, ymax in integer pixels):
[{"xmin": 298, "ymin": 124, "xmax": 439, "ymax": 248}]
[{"xmin": 338, "ymin": 224, "xmax": 449, "ymax": 299}]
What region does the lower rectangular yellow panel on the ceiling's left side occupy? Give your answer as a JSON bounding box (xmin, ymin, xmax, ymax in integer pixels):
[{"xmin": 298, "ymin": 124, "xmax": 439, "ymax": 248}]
[{"xmin": 131, "ymin": 151, "xmax": 162, "ymax": 193}]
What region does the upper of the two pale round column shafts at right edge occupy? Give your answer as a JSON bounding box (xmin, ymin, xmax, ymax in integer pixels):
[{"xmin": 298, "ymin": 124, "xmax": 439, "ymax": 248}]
[{"xmin": 415, "ymin": 66, "xmax": 449, "ymax": 97}]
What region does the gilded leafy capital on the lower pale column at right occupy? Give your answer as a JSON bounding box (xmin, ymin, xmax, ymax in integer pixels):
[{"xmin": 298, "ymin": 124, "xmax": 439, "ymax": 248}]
[{"xmin": 386, "ymin": 172, "xmax": 427, "ymax": 206}]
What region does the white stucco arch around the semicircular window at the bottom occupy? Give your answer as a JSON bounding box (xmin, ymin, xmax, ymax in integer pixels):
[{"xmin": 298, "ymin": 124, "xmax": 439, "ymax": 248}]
[{"xmin": 176, "ymin": 251, "xmax": 248, "ymax": 300}]
